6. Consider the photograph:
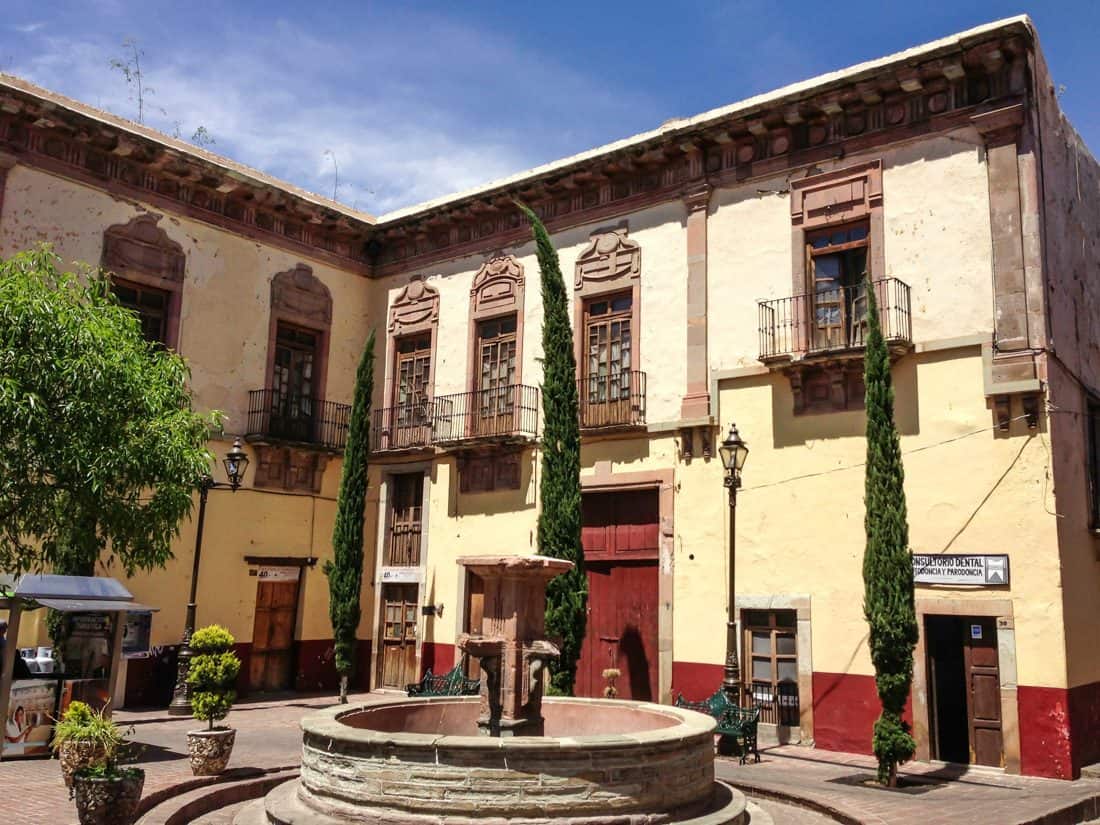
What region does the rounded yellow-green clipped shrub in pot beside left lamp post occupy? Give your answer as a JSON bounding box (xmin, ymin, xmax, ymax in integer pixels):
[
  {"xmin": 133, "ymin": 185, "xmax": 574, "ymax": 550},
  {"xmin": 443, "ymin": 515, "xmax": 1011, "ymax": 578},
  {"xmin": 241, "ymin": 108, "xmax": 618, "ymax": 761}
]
[{"xmin": 187, "ymin": 625, "xmax": 241, "ymax": 777}]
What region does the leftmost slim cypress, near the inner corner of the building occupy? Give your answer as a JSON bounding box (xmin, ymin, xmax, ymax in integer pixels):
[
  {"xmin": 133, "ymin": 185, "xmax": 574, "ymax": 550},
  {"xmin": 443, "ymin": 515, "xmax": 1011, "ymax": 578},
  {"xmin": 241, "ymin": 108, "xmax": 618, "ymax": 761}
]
[{"xmin": 325, "ymin": 330, "xmax": 374, "ymax": 704}]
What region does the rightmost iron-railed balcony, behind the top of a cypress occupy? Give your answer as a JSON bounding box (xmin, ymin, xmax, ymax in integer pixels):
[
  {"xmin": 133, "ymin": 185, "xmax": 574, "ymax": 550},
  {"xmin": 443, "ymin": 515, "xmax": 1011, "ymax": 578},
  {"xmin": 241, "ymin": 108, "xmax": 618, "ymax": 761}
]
[{"xmin": 759, "ymin": 278, "xmax": 913, "ymax": 363}]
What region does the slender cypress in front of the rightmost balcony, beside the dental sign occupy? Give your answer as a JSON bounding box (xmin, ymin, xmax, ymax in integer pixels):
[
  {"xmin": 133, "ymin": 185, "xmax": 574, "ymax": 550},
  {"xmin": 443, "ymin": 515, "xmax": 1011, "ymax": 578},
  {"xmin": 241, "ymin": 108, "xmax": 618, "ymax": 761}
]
[{"xmin": 864, "ymin": 278, "xmax": 917, "ymax": 788}]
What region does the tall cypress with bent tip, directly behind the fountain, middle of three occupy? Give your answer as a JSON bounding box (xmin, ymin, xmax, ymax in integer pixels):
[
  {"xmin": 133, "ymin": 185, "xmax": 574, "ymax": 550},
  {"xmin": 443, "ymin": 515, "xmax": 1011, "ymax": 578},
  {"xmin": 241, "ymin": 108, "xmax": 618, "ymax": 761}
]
[{"xmin": 518, "ymin": 204, "xmax": 589, "ymax": 695}]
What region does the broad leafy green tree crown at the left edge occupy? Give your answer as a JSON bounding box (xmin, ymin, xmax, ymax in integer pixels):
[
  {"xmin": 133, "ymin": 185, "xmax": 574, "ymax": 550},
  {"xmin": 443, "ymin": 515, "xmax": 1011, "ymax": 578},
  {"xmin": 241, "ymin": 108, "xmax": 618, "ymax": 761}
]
[{"xmin": 0, "ymin": 245, "xmax": 220, "ymax": 574}]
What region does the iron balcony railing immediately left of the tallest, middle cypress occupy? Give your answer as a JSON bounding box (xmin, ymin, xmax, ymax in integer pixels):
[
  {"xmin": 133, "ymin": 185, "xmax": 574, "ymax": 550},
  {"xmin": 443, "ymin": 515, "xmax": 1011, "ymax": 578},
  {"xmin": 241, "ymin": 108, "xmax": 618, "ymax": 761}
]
[{"xmin": 432, "ymin": 384, "xmax": 539, "ymax": 446}]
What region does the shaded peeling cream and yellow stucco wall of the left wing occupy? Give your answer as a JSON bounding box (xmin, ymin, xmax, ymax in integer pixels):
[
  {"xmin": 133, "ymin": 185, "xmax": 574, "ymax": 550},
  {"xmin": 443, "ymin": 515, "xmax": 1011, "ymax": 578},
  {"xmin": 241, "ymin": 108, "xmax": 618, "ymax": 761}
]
[{"xmin": 0, "ymin": 166, "xmax": 377, "ymax": 660}]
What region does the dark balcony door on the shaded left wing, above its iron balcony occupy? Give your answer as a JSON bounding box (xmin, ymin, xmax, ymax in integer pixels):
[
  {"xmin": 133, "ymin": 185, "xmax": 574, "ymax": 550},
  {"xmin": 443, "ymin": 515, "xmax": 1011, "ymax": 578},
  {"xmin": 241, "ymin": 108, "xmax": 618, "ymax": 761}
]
[{"xmin": 271, "ymin": 322, "xmax": 318, "ymax": 441}]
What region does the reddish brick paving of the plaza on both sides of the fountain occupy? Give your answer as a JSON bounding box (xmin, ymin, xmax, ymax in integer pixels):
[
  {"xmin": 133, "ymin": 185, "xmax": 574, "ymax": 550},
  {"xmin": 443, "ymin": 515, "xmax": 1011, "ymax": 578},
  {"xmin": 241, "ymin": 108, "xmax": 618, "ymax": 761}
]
[{"xmin": 0, "ymin": 695, "xmax": 1100, "ymax": 825}]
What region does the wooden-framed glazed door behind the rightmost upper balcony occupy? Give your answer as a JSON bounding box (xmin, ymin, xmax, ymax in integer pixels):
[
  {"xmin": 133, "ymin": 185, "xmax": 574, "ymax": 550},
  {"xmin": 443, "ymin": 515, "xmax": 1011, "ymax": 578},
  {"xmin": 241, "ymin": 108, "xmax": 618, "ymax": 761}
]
[{"xmin": 806, "ymin": 221, "xmax": 870, "ymax": 350}]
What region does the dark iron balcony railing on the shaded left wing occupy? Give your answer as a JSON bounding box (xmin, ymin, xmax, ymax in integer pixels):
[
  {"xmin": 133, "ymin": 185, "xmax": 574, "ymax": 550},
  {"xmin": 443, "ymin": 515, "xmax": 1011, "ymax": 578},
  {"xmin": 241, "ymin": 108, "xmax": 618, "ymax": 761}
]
[{"xmin": 245, "ymin": 388, "xmax": 351, "ymax": 452}]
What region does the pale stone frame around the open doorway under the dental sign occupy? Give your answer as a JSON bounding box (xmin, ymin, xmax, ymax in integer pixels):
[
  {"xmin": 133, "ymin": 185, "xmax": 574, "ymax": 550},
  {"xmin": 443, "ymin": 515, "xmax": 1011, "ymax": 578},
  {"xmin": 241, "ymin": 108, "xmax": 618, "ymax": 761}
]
[{"xmin": 912, "ymin": 596, "xmax": 1020, "ymax": 774}]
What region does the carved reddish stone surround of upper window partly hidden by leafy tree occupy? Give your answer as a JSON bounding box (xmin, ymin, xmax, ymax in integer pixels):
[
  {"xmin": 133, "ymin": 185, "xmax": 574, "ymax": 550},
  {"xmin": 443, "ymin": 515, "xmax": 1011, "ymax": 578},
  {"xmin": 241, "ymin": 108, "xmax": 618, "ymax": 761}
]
[{"xmin": 100, "ymin": 215, "xmax": 187, "ymax": 350}]
